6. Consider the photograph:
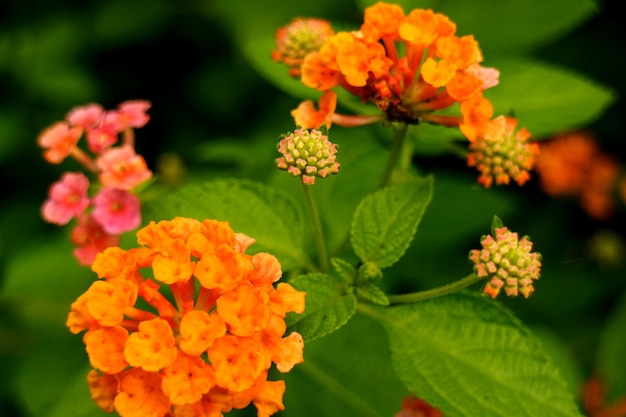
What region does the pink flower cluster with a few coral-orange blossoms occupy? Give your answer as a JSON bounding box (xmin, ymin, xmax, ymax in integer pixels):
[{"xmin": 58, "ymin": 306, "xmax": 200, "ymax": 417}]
[{"xmin": 37, "ymin": 100, "xmax": 152, "ymax": 265}]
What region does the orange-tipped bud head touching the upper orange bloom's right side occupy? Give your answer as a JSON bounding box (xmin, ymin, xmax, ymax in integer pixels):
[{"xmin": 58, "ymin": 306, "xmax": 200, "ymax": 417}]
[{"xmin": 467, "ymin": 116, "xmax": 539, "ymax": 188}]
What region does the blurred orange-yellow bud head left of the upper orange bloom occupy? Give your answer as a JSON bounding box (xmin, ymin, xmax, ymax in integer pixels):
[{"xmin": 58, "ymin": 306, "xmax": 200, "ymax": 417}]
[{"xmin": 272, "ymin": 17, "xmax": 334, "ymax": 77}]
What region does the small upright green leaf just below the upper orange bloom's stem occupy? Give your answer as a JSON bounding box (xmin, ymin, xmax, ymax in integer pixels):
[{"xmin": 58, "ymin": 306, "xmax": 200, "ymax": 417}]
[{"xmin": 350, "ymin": 177, "xmax": 433, "ymax": 268}]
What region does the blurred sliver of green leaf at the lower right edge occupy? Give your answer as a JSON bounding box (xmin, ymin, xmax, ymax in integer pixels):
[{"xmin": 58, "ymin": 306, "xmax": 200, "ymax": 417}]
[{"xmin": 598, "ymin": 293, "xmax": 626, "ymax": 400}]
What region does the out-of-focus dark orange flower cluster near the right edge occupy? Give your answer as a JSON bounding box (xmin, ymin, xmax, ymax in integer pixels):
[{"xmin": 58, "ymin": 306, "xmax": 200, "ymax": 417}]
[{"xmin": 535, "ymin": 131, "xmax": 626, "ymax": 219}]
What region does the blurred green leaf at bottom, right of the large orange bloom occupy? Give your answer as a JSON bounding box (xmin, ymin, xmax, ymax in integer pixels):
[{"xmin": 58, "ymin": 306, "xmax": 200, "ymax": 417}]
[{"xmin": 280, "ymin": 314, "xmax": 407, "ymax": 417}]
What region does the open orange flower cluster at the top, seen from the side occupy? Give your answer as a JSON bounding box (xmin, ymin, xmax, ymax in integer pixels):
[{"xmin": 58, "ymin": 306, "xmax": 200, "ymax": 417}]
[{"xmin": 276, "ymin": 2, "xmax": 498, "ymax": 140}]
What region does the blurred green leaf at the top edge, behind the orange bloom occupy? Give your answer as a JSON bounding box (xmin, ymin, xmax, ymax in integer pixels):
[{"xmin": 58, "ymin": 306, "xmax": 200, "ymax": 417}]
[{"xmin": 359, "ymin": 0, "xmax": 597, "ymax": 54}]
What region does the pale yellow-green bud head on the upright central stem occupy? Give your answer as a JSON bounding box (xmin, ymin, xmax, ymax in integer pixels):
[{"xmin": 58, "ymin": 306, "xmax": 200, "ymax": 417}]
[{"xmin": 276, "ymin": 129, "xmax": 339, "ymax": 184}]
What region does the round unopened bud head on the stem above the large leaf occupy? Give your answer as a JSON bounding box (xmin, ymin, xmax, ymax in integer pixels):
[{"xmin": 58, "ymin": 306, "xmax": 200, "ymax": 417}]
[{"xmin": 469, "ymin": 227, "xmax": 541, "ymax": 298}]
